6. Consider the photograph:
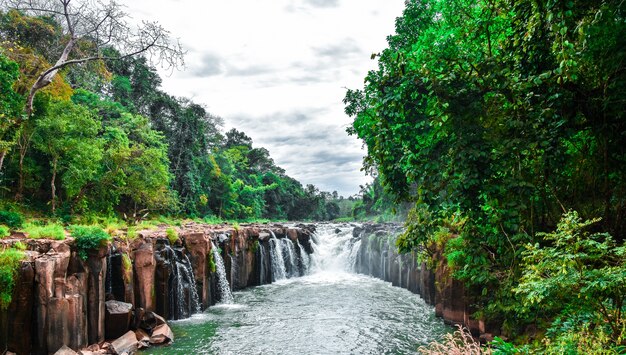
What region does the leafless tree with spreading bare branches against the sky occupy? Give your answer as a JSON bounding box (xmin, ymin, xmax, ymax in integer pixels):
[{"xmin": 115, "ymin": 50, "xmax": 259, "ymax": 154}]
[{"xmin": 0, "ymin": 0, "xmax": 185, "ymax": 115}]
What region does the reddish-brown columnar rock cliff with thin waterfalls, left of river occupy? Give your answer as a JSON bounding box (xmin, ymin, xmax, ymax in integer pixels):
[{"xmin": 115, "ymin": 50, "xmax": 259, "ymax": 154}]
[{"xmin": 0, "ymin": 223, "xmax": 313, "ymax": 354}]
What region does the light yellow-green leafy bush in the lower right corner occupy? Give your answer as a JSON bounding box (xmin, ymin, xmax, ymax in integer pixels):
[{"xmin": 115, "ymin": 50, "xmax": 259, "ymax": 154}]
[{"xmin": 515, "ymin": 212, "xmax": 626, "ymax": 350}]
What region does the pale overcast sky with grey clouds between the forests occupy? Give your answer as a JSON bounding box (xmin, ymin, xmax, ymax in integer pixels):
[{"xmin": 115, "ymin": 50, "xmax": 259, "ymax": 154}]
[{"xmin": 126, "ymin": 0, "xmax": 404, "ymax": 196}]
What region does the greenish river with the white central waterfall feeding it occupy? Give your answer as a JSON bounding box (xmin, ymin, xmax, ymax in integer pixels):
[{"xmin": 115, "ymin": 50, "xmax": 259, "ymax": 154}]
[{"xmin": 144, "ymin": 225, "xmax": 449, "ymax": 355}]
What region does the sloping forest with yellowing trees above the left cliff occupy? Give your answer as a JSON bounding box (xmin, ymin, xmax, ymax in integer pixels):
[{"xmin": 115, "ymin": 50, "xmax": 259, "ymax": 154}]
[{"xmin": 0, "ymin": 6, "xmax": 356, "ymax": 222}]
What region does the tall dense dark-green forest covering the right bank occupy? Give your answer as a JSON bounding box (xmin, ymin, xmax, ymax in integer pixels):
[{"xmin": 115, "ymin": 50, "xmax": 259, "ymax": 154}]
[{"xmin": 344, "ymin": 0, "xmax": 626, "ymax": 354}]
